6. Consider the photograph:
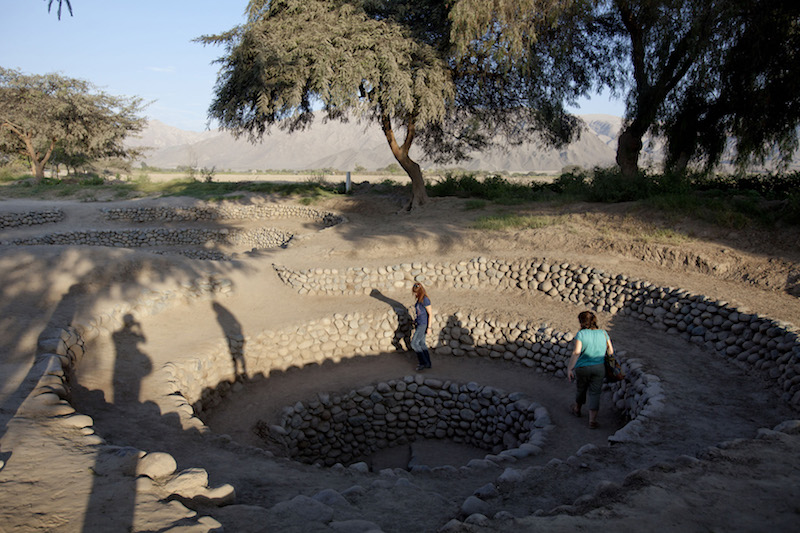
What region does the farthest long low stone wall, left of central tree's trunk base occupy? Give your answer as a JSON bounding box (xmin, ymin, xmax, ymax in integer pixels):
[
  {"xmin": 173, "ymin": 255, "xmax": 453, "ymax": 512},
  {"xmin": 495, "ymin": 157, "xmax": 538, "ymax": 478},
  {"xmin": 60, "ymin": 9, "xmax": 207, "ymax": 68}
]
[{"xmin": 102, "ymin": 204, "xmax": 345, "ymax": 227}]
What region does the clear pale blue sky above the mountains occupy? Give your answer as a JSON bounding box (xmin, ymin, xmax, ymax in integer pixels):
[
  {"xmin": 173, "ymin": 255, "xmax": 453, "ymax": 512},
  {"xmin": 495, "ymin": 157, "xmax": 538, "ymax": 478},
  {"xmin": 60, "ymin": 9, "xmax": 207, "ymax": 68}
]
[{"xmin": 0, "ymin": 0, "xmax": 623, "ymax": 131}]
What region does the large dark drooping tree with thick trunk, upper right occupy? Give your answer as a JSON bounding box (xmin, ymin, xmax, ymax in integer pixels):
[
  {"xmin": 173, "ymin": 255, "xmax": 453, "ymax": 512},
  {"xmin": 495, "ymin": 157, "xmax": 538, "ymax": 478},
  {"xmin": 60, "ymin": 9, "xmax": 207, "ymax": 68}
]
[{"xmin": 451, "ymin": 0, "xmax": 799, "ymax": 179}]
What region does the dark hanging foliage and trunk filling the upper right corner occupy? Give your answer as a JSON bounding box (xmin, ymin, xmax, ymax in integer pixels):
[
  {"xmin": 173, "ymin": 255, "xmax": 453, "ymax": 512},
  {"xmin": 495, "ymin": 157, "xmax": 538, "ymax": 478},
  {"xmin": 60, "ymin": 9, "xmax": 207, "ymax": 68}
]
[{"xmin": 450, "ymin": 0, "xmax": 800, "ymax": 180}]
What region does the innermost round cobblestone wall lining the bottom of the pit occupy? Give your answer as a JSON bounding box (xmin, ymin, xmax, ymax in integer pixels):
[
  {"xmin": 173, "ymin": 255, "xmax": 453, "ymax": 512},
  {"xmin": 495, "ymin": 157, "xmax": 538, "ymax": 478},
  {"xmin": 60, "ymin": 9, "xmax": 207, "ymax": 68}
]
[{"xmin": 272, "ymin": 375, "xmax": 550, "ymax": 467}]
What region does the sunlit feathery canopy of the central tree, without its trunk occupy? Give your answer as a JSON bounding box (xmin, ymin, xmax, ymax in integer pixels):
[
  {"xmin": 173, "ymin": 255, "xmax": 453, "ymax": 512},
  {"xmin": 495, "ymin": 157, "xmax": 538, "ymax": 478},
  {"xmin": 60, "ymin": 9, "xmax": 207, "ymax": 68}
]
[{"xmin": 201, "ymin": 0, "xmax": 454, "ymax": 142}]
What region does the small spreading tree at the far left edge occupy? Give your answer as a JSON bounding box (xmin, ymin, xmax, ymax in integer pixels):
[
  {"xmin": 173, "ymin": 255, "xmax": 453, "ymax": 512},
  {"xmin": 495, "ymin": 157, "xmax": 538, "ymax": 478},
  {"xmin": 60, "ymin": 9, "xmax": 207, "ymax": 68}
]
[{"xmin": 0, "ymin": 68, "xmax": 145, "ymax": 183}]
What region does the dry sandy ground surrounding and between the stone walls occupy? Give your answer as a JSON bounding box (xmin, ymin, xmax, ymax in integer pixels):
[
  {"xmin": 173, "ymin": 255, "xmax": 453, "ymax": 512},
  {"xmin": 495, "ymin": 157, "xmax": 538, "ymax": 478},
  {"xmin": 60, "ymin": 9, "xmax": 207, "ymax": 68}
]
[{"xmin": 0, "ymin": 185, "xmax": 800, "ymax": 533}]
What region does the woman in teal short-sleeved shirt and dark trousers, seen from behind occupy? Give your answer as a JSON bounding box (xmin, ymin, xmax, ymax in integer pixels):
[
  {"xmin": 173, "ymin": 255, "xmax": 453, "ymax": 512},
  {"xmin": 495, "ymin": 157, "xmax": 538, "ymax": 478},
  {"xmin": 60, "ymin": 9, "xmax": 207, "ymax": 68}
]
[{"xmin": 567, "ymin": 311, "xmax": 614, "ymax": 429}]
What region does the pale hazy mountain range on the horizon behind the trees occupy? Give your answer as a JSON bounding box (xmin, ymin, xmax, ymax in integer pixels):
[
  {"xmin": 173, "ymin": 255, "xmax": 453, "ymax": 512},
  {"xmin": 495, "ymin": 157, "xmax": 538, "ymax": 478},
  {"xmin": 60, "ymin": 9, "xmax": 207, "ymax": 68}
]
[{"xmin": 127, "ymin": 115, "xmax": 622, "ymax": 172}]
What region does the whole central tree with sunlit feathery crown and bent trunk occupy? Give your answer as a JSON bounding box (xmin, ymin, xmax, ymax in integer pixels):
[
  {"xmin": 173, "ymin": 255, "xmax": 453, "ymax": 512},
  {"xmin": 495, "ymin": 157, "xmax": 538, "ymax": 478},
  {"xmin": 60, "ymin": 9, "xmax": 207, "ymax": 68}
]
[{"xmin": 199, "ymin": 0, "xmax": 574, "ymax": 209}]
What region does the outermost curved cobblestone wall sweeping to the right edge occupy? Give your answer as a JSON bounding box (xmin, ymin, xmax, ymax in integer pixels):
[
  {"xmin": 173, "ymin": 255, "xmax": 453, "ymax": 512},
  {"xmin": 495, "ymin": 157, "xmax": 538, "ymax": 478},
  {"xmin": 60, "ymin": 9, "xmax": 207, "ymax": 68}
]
[{"xmin": 275, "ymin": 257, "xmax": 800, "ymax": 408}]
